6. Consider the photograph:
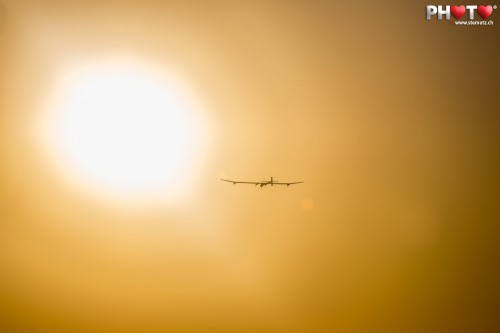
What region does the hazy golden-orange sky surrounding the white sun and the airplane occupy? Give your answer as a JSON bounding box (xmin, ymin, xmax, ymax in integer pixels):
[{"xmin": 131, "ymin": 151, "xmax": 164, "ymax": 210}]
[{"xmin": 0, "ymin": 0, "xmax": 500, "ymax": 332}]
